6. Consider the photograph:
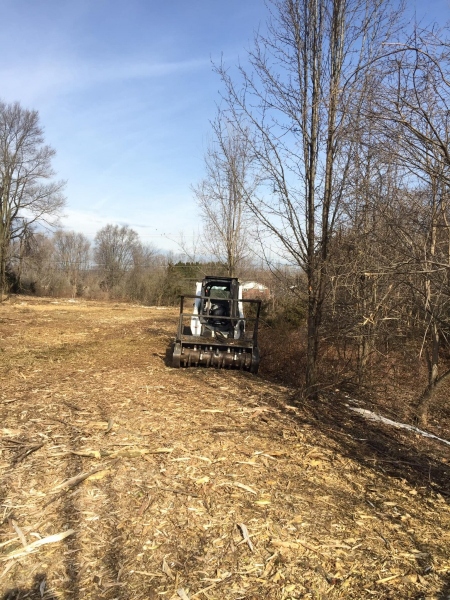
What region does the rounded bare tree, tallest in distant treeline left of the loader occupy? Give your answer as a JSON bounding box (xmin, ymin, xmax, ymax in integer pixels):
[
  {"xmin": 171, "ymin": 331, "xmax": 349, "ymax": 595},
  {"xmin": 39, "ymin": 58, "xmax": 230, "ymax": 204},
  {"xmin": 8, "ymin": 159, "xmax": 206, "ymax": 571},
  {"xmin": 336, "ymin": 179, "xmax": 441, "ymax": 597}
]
[{"xmin": 94, "ymin": 225, "xmax": 141, "ymax": 290}]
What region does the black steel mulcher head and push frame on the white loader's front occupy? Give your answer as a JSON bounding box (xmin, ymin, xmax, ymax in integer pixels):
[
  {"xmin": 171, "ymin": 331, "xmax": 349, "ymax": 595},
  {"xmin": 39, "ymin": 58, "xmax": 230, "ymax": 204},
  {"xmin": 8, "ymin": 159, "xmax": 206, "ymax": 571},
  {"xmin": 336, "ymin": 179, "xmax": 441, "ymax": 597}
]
[{"xmin": 172, "ymin": 295, "xmax": 261, "ymax": 373}]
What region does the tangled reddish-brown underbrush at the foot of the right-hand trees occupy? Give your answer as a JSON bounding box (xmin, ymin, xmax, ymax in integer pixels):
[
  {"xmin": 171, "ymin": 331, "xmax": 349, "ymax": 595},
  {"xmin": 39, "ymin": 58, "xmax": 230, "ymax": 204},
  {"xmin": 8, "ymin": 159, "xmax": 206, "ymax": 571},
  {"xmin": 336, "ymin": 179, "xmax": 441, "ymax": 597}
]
[{"xmin": 259, "ymin": 322, "xmax": 450, "ymax": 435}]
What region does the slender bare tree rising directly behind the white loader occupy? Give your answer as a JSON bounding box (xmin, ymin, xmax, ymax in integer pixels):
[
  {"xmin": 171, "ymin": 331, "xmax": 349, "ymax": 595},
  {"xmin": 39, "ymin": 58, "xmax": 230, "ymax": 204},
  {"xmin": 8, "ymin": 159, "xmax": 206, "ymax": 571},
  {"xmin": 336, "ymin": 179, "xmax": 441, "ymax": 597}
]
[{"xmin": 193, "ymin": 113, "xmax": 256, "ymax": 277}]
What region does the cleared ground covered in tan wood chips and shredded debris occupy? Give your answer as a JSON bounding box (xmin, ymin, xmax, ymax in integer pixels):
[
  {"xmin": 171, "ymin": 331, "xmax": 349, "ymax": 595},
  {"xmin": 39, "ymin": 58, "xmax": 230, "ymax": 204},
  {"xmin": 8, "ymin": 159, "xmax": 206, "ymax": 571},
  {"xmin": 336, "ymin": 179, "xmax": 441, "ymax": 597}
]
[{"xmin": 0, "ymin": 298, "xmax": 450, "ymax": 600}]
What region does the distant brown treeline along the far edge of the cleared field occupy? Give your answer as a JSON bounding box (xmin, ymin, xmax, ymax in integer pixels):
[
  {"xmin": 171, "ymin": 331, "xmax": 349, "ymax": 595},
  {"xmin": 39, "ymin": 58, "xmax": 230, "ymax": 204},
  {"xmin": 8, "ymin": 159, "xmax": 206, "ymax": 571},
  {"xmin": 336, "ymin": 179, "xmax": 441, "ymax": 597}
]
[{"xmin": 7, "ymin": 225, "xmax": 274, "ymax": 306}]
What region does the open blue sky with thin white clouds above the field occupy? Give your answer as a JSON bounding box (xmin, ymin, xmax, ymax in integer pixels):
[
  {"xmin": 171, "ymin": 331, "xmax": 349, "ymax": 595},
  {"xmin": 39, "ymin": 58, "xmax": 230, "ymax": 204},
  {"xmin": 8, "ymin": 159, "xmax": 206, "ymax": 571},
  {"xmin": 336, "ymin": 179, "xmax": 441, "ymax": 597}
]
[{"xmin": 0, "ymin": 0, "xmax": 450, "ymax": 252}]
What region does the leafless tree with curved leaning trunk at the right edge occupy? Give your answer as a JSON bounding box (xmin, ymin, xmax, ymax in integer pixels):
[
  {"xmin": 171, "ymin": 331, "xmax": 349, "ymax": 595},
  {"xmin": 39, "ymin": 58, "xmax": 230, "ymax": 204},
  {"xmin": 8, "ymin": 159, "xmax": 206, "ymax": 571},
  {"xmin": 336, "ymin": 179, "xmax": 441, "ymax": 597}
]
[{"xmin": 373, "ymin": 27, "xmax": 450, "ymax": 422}]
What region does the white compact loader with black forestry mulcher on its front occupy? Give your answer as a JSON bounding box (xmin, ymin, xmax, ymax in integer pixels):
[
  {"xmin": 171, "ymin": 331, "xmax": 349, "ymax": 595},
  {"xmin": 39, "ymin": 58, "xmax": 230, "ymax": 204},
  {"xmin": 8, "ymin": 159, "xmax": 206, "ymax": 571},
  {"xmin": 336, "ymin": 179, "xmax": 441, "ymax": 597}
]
[{"xmin": 172, "ymin": 276, "xmax": 261, "ymax": 373}]
